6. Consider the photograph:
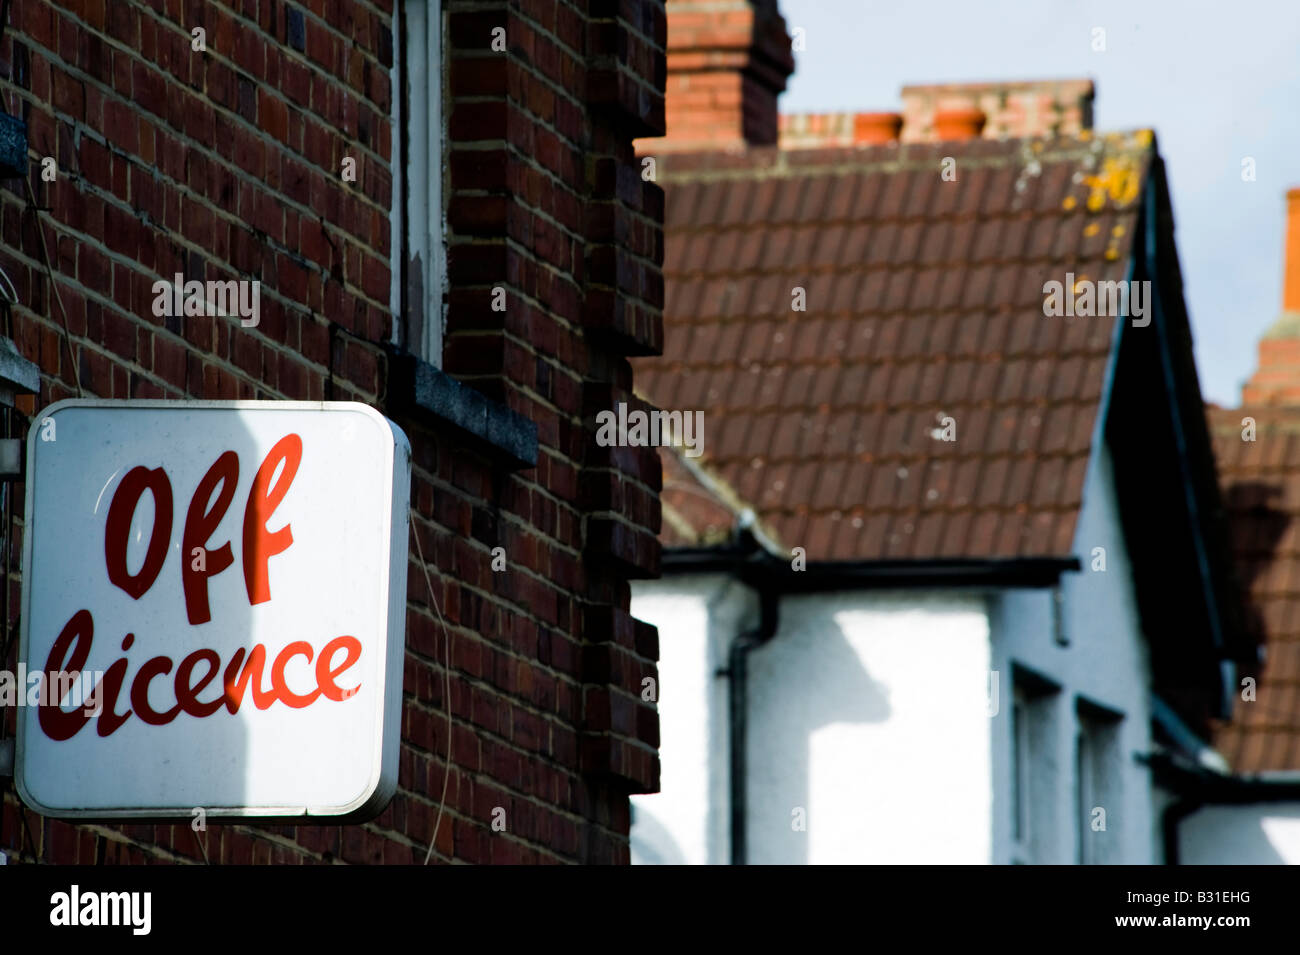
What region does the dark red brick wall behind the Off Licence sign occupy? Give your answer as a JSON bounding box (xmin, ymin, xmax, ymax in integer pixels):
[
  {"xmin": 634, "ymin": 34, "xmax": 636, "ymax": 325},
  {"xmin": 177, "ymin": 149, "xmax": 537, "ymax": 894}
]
[{"xmin": 0, "ymin": 0, "xmax": 664, "ymax": 863}]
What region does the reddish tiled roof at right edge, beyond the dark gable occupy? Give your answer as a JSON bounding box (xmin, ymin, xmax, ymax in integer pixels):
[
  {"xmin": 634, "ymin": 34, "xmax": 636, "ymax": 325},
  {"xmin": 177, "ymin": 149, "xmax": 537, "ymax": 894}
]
[{"xmin": 1208, "ymin": 408, "xmax": 1300, "ymax": 772}]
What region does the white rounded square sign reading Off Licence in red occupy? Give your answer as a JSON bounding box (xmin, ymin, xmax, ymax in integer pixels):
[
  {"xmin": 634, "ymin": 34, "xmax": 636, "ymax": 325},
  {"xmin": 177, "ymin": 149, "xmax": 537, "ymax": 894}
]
[{"xmin": 14, "ymin": 400, "xmax": 411, "ymax": 819}]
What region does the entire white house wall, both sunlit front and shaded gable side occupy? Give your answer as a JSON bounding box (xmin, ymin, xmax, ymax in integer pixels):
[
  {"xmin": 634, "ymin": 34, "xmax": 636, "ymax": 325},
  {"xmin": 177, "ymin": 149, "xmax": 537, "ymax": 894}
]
[{"xmin": 632, "ymin": 441, "xmax": 1164, "ymax": 864}]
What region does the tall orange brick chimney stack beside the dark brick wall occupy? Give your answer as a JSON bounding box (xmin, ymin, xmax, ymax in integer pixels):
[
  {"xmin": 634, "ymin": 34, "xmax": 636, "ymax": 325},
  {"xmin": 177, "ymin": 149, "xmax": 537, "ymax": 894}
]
[{"xmin": 650, "ymin": 0, "xmax": 794, "ymax": 152}]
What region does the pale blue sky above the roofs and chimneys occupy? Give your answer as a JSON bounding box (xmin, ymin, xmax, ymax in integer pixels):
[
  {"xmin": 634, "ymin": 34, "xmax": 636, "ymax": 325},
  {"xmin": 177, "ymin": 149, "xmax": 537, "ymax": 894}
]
[{"xmin": 779, "ymin": 0, "xmax": 1300, "ymax": 407}]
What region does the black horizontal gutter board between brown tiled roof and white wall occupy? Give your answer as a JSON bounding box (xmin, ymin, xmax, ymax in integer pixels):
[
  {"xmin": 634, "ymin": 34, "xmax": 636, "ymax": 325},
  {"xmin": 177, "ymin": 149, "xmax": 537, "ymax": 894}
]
[{"xmin": 662, "ymin": 544, "xmax": 1082, "ymax": 594}]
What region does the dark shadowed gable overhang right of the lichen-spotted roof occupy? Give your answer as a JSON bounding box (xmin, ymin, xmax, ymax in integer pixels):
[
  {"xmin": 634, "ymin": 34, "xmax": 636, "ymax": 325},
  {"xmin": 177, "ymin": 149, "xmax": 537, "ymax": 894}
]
[{"xmin": 1101, "ymin": 164, "xmax": 1242, "ymax": 729}]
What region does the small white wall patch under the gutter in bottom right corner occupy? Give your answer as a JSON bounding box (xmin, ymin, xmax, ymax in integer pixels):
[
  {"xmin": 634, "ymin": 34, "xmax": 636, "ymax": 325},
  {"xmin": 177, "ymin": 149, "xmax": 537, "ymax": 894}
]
[{"xmin": 1178, "ymin": 803, "xmax": 1300, "ymax": 865}]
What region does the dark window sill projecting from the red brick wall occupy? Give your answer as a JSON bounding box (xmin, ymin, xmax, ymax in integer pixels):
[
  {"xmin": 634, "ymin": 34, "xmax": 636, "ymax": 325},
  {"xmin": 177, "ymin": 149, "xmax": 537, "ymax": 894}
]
[{"xmin": 389, "ymin": 352, "xmax": 537, "ymax": 470}]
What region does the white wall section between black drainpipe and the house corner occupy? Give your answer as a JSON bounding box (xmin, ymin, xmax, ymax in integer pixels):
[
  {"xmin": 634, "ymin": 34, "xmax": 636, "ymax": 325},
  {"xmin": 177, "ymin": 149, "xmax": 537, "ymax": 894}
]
[{"xmin": 746, "ymin": 591, "xmax": 992, "ymax": 864}]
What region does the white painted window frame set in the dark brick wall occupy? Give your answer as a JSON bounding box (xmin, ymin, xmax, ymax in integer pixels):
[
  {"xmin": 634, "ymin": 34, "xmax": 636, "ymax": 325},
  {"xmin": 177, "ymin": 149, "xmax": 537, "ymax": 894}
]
[{"xmin": 390, "ymin": 0, "xmax": 447, "ymax": 368}]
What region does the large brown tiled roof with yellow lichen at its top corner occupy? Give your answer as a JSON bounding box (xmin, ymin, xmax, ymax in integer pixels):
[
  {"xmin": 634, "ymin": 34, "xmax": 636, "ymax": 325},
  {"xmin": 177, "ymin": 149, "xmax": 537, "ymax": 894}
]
[{"xmin": 636, "ymin": 131, "xmax": 1154, "ymax": 560}]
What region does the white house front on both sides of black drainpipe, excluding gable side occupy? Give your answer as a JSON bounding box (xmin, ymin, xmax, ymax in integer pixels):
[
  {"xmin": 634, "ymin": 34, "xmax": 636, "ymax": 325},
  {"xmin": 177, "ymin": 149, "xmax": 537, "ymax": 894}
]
[{"xmin": 632, "ymin": 576, "xmax": 992, "ymax": 864}]
